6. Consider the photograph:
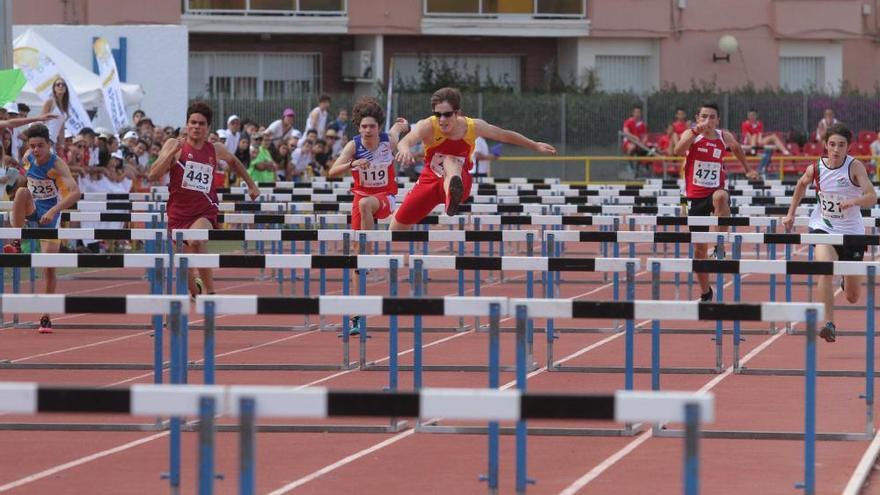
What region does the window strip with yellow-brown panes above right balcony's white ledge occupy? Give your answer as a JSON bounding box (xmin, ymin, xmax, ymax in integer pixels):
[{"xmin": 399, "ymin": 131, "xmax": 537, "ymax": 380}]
[{"xmin": 424, "ymin": 0, "xmax": 587, "ymax": 18}]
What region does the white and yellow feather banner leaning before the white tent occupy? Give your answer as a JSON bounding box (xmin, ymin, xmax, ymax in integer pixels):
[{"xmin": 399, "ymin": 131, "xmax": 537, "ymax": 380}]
[{"xmin": 12, "ymin": 46, "xmax": 92, "ymax": 141}]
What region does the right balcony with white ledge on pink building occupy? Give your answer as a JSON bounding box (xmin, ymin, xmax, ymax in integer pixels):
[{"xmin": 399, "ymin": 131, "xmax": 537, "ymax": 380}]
[{"xmin": 422, "ymin": 0, "xmax": 590, "ymax": 37}]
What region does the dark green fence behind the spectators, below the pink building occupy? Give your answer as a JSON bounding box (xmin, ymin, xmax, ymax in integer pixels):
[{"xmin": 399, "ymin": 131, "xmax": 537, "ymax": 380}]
[{"xmin": 196, "ymin": 92, "xmax": 880, "ymax": 154}]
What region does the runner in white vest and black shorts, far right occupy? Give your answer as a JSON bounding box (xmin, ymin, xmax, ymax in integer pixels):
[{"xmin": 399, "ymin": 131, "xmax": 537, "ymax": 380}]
[{"xmin": 782, "ymin": 123, "xmax": 877, "ymax": 342}]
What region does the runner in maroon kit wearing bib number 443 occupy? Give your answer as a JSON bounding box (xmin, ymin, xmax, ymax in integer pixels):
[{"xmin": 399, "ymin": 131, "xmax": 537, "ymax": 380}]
[{"xmin": 149, "ymin": 102, "xmax": 260, "ymax": 297}]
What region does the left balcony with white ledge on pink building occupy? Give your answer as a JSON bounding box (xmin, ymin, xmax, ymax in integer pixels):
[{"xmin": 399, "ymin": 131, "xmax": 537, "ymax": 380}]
[{"xmin": 181, "ymin": 0, "xmax": 348, "ymax": 34}]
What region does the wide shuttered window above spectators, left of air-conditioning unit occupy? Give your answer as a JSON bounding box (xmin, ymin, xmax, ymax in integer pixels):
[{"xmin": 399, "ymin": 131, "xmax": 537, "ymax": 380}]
[{"xmin": 189, "ymin": 52, "xmax": 321, "ymax": 99}]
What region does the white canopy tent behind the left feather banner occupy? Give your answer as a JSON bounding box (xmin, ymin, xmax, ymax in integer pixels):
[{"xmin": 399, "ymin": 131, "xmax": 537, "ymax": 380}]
[{"xmin": 13, "ymin": 29, "xmax": 144, "ymax": 115}]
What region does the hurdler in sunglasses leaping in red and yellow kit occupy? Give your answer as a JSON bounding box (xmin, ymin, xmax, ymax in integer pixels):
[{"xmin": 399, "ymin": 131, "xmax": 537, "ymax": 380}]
[{"xmin": 391, "ymin": 88, "xmax": 556, "ymax": 230}]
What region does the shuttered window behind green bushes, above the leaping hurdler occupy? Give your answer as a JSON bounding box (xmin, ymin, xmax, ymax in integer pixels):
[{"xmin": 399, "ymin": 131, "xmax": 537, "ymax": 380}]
[{"xmin": 394, "ymin": 54, "xmax": 521, "ymax": 91}]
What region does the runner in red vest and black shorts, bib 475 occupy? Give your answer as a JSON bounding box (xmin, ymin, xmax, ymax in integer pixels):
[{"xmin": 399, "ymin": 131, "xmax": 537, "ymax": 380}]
[{"xmin": 674, "ymin": 103, "xmax": 758, "ymax": 301}]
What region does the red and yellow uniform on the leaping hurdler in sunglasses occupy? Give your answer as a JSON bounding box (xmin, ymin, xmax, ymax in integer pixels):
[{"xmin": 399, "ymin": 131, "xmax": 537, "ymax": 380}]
[{"xmin": 394, "ymin": 117, "xmax": 477, "ymax": 225}]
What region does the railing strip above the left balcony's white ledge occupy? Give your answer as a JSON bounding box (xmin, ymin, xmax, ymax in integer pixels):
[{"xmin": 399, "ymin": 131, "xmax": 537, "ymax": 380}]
[{"xmin": 183, "ymin": 0, "xmax": 348, "ymax": 17}]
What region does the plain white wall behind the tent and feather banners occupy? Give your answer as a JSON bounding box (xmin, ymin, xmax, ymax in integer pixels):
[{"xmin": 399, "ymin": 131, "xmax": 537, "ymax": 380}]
[{"xmin": 13, "ymin": 25, "xmax": 189, "ymax": 127}]
